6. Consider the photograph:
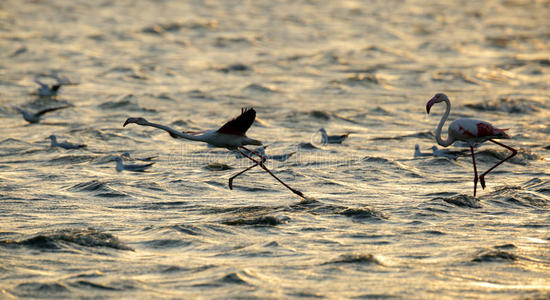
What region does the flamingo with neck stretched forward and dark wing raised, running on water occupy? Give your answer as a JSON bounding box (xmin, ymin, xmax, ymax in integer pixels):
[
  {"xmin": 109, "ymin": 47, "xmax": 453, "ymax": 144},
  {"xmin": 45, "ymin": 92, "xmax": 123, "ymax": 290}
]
[{"xmin": 122, "ymin": 108, "xmax": 304, "ymax": 198}]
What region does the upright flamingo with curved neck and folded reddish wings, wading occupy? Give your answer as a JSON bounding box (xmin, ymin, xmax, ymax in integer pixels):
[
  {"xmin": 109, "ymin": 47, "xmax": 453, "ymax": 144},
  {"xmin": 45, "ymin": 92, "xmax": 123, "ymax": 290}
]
[{"xmin": 426, "ymin": 93, "xmax": 518, "ymax": 198}]
